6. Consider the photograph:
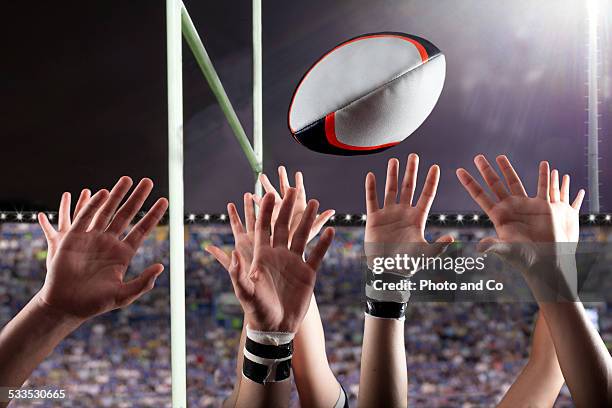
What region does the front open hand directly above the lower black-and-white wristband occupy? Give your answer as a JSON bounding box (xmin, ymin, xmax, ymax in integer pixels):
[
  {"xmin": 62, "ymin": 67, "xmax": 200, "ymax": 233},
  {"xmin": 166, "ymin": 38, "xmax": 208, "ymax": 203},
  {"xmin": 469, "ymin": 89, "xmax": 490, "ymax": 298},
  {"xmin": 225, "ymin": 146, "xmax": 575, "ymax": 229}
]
[{"xmin": 229, "ymin": 188, "xmax": 334, "ymax": 333}]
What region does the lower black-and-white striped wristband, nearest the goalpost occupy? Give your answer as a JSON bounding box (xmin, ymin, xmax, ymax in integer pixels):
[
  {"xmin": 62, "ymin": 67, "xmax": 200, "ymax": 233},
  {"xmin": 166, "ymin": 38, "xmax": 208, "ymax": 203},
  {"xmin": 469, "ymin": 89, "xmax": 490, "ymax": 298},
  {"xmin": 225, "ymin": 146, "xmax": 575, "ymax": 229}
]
[{"xmin": 242, "ymin": 326, "xmax": 295, "ymax": 384}]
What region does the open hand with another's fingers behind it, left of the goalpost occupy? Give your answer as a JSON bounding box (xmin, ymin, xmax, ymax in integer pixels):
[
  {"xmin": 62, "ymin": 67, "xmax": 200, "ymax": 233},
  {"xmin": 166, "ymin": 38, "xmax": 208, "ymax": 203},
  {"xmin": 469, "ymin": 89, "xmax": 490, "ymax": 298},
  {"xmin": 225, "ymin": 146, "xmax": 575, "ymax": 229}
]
[{"xmin": 37, "ymin": 177, "xmax": 168, "ymax": 320}]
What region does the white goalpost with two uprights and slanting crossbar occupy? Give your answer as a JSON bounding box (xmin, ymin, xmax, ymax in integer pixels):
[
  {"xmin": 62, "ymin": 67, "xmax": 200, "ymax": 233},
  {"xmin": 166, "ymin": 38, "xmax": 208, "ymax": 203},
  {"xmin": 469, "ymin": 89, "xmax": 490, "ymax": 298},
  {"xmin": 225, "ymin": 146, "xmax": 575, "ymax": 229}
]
[{"xmin": 166, "ymin": 0, "xmax": 263, "ymax": 408}]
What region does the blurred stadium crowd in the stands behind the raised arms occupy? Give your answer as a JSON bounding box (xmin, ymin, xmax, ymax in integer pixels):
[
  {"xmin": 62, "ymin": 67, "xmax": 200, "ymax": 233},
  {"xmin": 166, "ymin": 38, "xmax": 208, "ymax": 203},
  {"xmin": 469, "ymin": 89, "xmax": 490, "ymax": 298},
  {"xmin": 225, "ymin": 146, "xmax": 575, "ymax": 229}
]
[{"xmin": 0, "ymin": 223, "xmax": 612, "ymax": 407}]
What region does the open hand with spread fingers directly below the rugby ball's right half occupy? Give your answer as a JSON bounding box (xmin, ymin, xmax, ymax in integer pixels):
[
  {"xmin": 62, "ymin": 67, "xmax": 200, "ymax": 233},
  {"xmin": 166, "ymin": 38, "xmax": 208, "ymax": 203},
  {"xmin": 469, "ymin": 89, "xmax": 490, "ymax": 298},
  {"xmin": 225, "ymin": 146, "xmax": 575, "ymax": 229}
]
[{"xmin": 365, "ymin": 153, "xmax": 453, "ymax": 256}]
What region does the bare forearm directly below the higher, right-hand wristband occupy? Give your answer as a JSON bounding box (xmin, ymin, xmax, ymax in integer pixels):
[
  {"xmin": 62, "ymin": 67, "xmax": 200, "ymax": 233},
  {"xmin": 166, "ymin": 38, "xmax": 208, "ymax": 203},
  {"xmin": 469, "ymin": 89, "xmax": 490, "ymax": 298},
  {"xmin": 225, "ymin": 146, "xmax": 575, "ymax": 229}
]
[{"xmin": 358, "ymin": 315, "xmax": 408, "ymax": 408}]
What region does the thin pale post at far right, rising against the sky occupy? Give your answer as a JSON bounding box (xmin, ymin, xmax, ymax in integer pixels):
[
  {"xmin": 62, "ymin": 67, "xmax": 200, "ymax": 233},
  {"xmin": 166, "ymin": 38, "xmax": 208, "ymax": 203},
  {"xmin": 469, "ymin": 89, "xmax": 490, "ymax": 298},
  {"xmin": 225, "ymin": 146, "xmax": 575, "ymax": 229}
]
[{"xmin": 586, "ymin": 0, "xmax": 599, "ymax": 213}]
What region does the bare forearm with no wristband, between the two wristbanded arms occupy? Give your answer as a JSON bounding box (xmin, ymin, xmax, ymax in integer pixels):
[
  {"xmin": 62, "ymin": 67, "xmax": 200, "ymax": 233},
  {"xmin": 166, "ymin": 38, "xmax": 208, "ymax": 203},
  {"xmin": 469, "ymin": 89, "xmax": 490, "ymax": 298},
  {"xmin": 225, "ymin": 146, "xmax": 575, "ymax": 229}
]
[{"xmin": 292, "ymin": 295, "xmax": 340, "ymax": 408}]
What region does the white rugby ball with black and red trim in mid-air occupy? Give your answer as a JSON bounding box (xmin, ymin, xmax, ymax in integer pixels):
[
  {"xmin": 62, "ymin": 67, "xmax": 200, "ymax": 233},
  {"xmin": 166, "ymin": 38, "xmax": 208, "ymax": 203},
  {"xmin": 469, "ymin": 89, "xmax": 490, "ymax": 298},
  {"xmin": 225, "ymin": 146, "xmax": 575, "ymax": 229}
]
[{"xmin": 288, "ymin": 32, "xmax": 446, "ymax": 155}]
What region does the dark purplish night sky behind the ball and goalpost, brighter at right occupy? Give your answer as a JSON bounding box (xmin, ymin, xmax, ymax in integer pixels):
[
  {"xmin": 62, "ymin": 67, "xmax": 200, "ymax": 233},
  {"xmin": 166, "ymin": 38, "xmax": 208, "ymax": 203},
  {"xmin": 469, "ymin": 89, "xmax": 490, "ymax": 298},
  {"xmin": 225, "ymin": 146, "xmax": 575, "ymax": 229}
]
[{"xmin": 0, "ymin": 0, "xmax": 612, "ymax": 212}]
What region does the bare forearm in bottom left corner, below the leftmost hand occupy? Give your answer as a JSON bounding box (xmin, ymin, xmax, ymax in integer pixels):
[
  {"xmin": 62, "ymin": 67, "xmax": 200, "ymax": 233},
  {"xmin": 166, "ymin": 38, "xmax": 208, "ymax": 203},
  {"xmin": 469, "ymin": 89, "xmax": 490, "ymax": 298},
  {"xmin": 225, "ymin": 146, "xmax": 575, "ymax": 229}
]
[{"xmin": 0, "ymin": 296, "xmax": 80, "ymax": 387}]
